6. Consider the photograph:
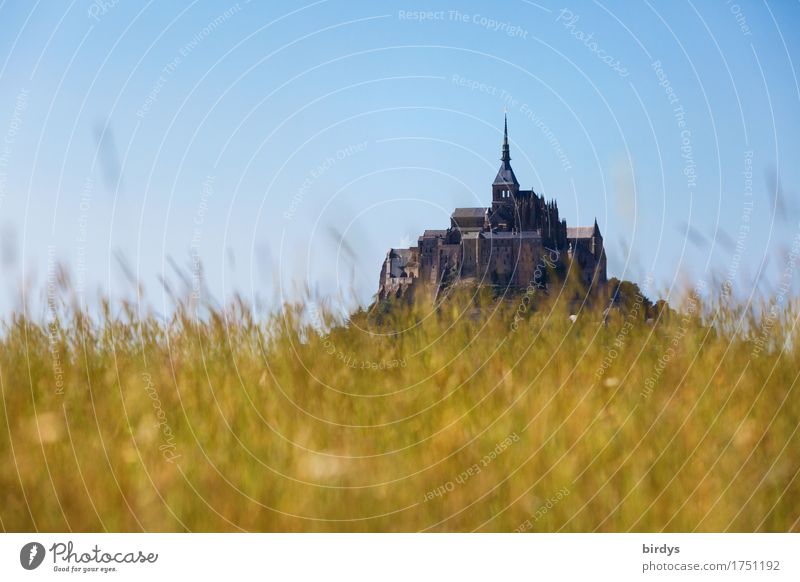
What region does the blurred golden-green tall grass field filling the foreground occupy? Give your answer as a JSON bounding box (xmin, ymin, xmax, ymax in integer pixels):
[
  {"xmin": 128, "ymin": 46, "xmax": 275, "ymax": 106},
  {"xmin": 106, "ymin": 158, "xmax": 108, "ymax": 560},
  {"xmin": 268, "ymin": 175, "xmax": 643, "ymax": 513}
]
[{"xmin": 0, "ymin": 282, "xmax": 800, "ymax": 532}]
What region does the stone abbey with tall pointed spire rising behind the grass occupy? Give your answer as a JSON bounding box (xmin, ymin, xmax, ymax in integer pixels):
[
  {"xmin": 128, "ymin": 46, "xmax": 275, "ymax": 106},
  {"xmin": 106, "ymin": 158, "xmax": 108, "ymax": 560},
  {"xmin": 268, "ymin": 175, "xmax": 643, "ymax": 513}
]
[{"xmin": 378, "ymin": 120, "xmax": 606, "ymax": 299}]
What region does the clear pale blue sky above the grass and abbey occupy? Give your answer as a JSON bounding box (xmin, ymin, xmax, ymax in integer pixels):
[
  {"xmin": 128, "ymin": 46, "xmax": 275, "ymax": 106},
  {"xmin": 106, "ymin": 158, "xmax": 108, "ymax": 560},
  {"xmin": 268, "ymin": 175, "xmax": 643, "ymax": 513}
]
[{"xmin": 0, "ymin": 0, "xmax": 800, "ymax": 320}]
